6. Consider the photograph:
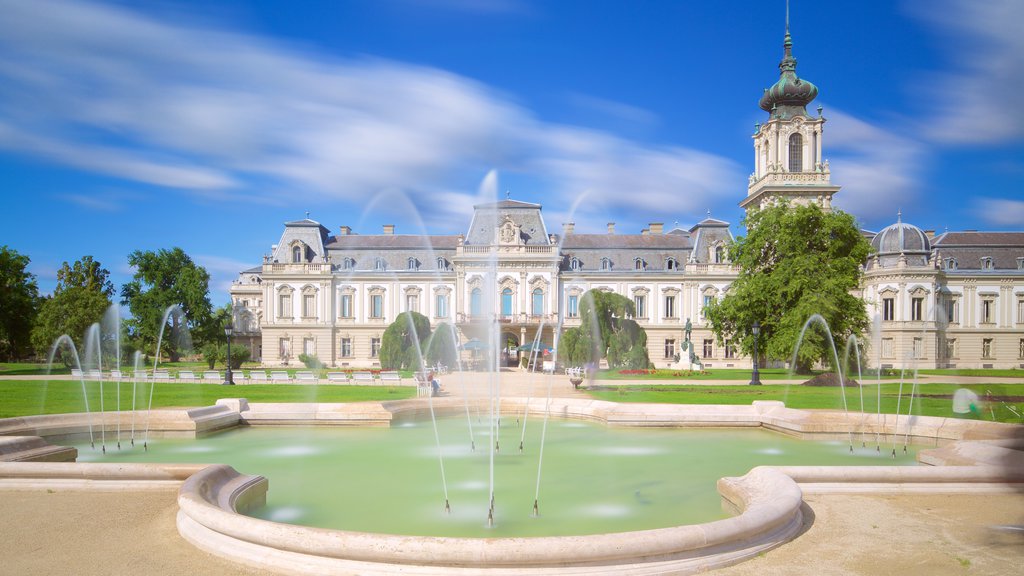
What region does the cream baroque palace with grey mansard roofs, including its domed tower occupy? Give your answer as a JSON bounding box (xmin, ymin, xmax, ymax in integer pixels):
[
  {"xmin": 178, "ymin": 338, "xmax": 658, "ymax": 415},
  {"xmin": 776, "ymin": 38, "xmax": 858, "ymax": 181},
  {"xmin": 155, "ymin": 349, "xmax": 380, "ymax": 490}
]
[{"xmin": 230, "ymin": 25, "xmax": 1024, "ymax": 368}]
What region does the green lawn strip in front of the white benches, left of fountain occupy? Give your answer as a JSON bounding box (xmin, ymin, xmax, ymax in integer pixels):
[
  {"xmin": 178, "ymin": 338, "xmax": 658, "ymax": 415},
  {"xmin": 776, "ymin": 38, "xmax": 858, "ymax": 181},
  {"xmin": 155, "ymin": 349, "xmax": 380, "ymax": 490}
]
[{"xmin": 0, "ymin": 380, "xmax": 416, "ymax": 418}]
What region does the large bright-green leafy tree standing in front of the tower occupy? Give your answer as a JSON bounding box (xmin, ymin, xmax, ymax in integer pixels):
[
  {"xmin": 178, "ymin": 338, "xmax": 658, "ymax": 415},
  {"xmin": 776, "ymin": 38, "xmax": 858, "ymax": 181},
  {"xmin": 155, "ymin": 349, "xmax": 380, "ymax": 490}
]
[{"xmin": 705, "ymin": 204, "xmax": 870, "ymax": 372}]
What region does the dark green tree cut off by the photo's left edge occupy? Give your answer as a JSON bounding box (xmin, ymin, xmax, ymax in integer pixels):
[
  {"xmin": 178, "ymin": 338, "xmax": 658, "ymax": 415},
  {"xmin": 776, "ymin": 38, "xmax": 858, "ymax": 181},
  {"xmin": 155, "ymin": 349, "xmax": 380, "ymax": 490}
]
[{"xmin": 0, "ymin": 246, "xmax": 39, "ymax": 361}]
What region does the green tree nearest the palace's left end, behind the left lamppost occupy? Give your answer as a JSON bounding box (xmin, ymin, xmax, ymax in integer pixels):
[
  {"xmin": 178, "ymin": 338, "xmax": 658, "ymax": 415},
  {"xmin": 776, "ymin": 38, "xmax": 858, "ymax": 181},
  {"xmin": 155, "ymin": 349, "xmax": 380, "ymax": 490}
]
[{"xmin": 121, "ymin": 248, "xmax": 214, "ymax": 362}]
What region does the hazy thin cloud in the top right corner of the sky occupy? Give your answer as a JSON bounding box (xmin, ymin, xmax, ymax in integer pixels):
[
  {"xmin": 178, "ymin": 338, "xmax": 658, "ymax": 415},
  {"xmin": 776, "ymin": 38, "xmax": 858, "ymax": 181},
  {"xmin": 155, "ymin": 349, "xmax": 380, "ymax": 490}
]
[{"xmin": 910, "ymin": 0, "xmax": 1024, "ymax": 145}]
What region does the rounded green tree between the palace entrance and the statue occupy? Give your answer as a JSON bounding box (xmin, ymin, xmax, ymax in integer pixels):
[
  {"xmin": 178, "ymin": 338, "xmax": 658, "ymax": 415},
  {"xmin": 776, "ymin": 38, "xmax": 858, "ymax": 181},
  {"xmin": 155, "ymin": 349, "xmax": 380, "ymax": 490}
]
[{"xmin": 559, "ymin": 290, "xmax": 650, "ymax": 368}]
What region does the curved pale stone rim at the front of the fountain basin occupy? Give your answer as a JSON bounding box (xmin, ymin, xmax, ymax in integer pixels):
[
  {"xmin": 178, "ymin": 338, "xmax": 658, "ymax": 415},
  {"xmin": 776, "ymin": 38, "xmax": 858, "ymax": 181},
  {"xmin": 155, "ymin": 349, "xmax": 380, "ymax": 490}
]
[{"xmin": 177, "ymin": 465, "xmax": 803, "ymax": 574}]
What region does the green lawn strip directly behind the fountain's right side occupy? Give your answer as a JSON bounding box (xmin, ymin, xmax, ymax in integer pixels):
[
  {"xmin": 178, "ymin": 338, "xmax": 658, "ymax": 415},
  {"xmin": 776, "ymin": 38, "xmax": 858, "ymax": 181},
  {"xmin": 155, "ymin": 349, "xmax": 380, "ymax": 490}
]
[{"xmin": 588, "ymin": 382, "xmax": 1024, "ymax": 423}]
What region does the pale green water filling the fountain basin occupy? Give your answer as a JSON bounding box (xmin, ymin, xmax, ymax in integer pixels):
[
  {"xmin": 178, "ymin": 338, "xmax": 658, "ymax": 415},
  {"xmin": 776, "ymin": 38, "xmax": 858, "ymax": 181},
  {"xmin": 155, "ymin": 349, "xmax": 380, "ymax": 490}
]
[{"xmin": 79, "ymin": 416, "xmax": 915, "ymax": 537}]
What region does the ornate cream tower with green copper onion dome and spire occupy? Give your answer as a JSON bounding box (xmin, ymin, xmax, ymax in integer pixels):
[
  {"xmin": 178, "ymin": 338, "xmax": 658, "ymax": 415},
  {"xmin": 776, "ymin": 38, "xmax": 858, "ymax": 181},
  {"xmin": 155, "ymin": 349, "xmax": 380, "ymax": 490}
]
[{"xmin": 739, "ymin": 13, "xmax": 840, "ymax": 215}]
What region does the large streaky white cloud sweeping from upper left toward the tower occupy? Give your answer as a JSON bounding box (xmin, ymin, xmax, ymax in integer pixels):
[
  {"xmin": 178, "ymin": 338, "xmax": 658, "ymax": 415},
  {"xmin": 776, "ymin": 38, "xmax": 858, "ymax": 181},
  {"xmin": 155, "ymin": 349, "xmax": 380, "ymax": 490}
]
[{"xmin": 0, "ymin": 0, "xmax": 742, "ymax": 228}]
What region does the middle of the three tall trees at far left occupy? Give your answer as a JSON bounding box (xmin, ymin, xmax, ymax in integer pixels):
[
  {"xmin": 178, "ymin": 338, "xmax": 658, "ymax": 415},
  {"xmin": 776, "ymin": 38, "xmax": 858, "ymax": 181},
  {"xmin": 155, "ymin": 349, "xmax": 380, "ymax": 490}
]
[{"xmin": 32, "ymin": 256, "xmax": 114, "ymax": 365}]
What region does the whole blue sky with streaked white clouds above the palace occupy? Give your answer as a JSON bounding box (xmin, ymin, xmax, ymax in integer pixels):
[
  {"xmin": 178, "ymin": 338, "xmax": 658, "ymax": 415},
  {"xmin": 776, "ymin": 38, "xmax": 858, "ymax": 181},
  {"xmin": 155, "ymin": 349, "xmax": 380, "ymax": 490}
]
[{"xmin": 0, "ymin": 0, "xmax": 1024, "ymax": 303}]
